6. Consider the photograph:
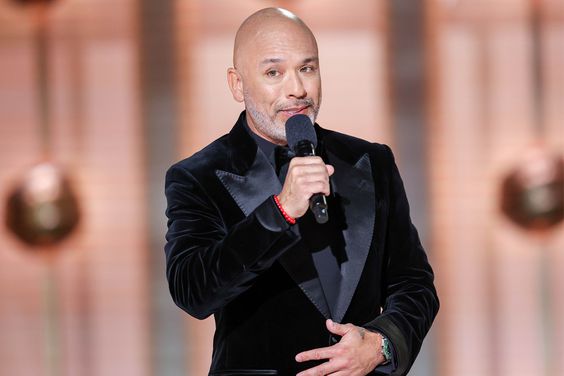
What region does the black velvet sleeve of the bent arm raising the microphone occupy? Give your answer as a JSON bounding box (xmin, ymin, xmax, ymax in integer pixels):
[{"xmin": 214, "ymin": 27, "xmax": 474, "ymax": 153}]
[{"xmin": 165, "ymin": 165, "xmax": 299, "ymax": 319}]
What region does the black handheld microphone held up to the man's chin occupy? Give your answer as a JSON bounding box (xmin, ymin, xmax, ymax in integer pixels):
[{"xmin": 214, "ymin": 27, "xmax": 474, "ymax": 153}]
[{"xmin": 286, "ymin": 114, "xmax": 329, "ymax": 224}]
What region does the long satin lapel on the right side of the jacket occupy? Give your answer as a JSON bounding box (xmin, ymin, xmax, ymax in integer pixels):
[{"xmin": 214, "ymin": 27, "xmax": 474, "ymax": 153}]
[{"xmin": 327, "ymin": 151, "xmax": 376, "ymax": 322}]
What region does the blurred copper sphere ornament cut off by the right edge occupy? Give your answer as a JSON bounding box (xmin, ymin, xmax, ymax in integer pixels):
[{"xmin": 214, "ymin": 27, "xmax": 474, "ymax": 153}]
[{"xmin": 501, "ymin": 149, "xmax": 564, "ymax": 230}]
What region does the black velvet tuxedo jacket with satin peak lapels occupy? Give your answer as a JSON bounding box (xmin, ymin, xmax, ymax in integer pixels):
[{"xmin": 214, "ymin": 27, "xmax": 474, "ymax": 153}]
[{"xmin": 165, "ymin": 112, "xmax": 439, "ymax": 375}]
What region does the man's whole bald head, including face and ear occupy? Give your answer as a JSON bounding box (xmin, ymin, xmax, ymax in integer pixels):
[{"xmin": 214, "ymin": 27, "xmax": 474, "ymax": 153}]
[{"xmin": 227, "ymin": 8, "xmax": 321, "ymax": 145}]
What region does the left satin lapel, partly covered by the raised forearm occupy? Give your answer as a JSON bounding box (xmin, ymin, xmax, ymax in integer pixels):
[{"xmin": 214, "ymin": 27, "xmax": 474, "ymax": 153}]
[{"xmin": 215, "ymin": 120, "xmax": 330, "ymax": 318}]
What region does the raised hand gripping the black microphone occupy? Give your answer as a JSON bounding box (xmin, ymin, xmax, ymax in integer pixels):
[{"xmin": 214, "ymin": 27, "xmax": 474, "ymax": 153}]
[{"xmin": 278, "ymin": 157, "xmax": 335, "ymax": 218}]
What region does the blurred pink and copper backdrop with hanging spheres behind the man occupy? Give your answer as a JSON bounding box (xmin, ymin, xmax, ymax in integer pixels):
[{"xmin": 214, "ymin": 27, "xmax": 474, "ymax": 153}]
[{"xmin": 0, "ymin": 0, "xmax": 564, "ymax": 376}]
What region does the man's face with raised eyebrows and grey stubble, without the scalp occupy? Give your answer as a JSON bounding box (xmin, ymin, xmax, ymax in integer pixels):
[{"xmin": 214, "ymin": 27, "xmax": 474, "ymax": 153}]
[{"xmin": 238, "ymin": 22, "xmax": 321, "ymax": 144}]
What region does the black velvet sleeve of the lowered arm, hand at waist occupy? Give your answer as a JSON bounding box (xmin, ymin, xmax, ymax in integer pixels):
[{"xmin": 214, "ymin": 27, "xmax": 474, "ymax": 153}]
[{"xmin": 364, "ymin": 147, "xmax": 439, "ymax": 375}]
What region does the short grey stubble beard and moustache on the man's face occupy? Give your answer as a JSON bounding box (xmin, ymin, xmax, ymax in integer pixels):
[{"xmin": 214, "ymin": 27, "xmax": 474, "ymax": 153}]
[{"xmin": 243, "ymin": 92, "xmax": 319, "ymax": 144}]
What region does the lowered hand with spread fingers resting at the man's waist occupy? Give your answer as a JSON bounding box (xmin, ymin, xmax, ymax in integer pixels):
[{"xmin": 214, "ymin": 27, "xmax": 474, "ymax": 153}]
[{"xmin": 296, "ymin": 320, "xmax": 385, "ymax": 376}]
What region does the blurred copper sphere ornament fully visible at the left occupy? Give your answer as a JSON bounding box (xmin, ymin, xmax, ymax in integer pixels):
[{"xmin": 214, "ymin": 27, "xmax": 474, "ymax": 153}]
[{"xmin": 6, "ymin": 163, "xmax": 79, "ymax": 246}]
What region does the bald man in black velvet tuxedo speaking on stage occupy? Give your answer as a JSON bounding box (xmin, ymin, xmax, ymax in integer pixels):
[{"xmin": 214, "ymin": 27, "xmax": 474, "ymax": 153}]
[{"xmin": 165, "ymin": 8, "xmax": 439, "ymax": 376}]
